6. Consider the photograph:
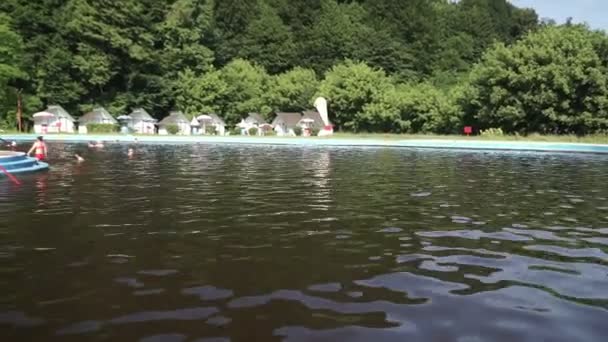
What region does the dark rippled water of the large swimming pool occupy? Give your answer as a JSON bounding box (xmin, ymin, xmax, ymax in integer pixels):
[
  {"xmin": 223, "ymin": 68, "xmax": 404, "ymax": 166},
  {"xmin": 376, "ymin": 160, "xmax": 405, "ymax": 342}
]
[{"xmin": 0, "ymin": 144, "xmax": 608, "ymax": 342}]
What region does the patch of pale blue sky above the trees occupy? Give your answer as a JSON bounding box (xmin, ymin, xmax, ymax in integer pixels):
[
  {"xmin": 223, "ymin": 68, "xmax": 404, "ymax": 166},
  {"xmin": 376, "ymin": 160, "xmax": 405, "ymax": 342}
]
[{"xmin": 511, "ymin": 0, "xmax": 608, "ymax": 30}]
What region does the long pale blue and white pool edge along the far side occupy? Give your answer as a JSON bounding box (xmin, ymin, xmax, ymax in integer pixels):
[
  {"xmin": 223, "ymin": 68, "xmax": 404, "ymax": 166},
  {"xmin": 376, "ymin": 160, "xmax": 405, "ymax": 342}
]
[{"xmin": 0, "ymin": 134, "xmax": 608, "ymax": 154}]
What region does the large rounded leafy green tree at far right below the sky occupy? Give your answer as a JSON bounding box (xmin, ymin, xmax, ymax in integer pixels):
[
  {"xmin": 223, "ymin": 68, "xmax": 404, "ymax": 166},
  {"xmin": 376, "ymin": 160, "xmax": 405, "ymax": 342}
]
[{"xmin": 467, "ymin": 26, "xmax": 608, "ymax": 134}]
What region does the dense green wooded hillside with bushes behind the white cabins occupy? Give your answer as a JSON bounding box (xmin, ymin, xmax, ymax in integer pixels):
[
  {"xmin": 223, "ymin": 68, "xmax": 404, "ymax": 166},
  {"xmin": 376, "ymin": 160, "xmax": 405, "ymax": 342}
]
[{"xmin": 0, "ymin": 0, "xmax": 608, "ymax": 133}]
